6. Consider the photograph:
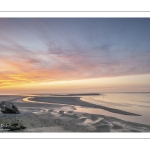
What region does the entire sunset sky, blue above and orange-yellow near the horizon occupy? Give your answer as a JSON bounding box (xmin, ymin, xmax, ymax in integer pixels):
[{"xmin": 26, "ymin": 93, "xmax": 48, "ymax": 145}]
[{"xmin": 0, "ymin": 18, "xmax": 150, "ymax": 94}]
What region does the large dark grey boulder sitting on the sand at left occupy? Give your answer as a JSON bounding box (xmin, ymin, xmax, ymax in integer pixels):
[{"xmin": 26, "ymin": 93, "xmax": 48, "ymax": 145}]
[{"xmin": 0, "ymin": 101, "xmax": 20, "ymax": 114}]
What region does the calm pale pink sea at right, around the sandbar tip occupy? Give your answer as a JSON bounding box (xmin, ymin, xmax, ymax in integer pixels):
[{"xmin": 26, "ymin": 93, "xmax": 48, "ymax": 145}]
[{"xmin": 76, "ymin": 93, "xmax": 150, "ymax": 125}]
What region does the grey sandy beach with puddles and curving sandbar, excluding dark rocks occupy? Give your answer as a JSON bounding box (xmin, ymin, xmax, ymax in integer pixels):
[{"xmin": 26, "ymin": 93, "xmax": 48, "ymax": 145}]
[{"xmin": 0, "ymin": 95, "xmax": 150, "ymax": 132}]
